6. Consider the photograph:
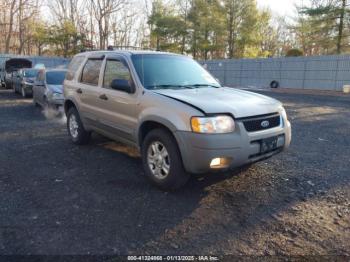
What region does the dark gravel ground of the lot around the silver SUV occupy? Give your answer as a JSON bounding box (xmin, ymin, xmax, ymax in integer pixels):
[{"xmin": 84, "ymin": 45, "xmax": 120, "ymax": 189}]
[{"xmin": 0, "ymin": 91, "xmax": 350, "ymax": 256}]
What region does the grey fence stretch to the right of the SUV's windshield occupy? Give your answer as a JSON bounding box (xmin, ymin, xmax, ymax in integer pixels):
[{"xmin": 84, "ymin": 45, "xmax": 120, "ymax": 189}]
[{"xmin": 200, "ymin": 56, "xmax": 350, "ymax": 91}]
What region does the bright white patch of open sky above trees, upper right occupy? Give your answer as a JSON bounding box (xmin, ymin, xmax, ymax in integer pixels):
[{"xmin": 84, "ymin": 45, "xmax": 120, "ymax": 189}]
[{"xmin": 257, "ymin": 0, "xmax": 308, "ymax": 16}]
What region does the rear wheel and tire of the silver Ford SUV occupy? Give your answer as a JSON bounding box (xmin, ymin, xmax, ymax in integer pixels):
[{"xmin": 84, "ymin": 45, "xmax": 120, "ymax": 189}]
[{"xmin": 67, "ymin": 107, "xmax": 91, "ymax": 145}]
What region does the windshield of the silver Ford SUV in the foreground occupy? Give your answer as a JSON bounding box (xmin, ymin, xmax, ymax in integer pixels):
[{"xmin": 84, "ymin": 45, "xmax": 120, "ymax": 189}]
[{"xmin": 132, "ymin": 54, "xmax": 220, "ymax": 89}]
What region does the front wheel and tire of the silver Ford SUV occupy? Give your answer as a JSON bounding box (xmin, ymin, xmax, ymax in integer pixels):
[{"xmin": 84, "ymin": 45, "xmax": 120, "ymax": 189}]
[{"xmin": 141, "ymin": 129, "xmax": 190, "ymax": 191}]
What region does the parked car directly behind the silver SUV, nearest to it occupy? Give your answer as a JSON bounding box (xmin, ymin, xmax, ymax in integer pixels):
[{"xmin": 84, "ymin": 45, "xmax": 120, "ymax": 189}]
[{"xmin": 33, "ymin": 69, "xmax": 67, "ymax": 109}]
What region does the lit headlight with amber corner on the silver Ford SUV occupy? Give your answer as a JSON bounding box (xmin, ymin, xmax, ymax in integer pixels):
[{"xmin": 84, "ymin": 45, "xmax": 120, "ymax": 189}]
[{"xmin": 191, "ymin": 116, "xmax": 235, "ymax": 134}]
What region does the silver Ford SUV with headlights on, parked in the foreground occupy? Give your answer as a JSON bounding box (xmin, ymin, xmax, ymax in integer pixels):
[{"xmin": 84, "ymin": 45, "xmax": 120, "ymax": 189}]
[{"xmin": 64, "ymin": 51, "xmax": 291, "ymax": 190}]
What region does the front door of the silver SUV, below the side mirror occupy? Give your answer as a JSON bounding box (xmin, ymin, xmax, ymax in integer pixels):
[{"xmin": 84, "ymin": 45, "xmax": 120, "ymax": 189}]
[{"xmin": 99, "ymin": 54, "xmax": 139, "ymax": 142}]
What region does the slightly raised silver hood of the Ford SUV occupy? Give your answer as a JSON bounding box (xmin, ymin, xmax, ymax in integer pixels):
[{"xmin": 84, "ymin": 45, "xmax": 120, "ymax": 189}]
[{"xmin": 154, "ymin": 87, "xmax": 282, "ymax": 118}]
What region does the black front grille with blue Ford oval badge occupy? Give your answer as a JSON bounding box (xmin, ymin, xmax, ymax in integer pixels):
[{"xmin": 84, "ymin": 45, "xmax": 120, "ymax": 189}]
[{"xmin": 243, "ymin": 114, "xmax": 281, "ymax": 132}]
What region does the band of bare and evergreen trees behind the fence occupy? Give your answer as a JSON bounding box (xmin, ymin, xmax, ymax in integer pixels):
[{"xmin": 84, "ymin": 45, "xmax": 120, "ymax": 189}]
[{"xmin": 0, "ymin": 0, "xmax": 350, "ymax": 60}]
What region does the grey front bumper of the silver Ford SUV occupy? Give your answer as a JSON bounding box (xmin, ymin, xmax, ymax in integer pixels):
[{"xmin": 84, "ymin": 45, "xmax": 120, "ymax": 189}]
[{"xmin": 174, "ymin": 119, "xmax": 292, "ymax": 174}]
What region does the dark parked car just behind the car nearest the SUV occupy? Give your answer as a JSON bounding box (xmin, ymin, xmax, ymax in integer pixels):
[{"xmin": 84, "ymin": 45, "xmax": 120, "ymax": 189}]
[{"xmin": 13, "ymin": 68, "xmax": 39, "ymax": 97}]
